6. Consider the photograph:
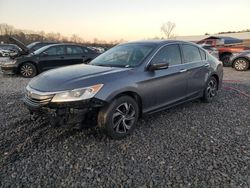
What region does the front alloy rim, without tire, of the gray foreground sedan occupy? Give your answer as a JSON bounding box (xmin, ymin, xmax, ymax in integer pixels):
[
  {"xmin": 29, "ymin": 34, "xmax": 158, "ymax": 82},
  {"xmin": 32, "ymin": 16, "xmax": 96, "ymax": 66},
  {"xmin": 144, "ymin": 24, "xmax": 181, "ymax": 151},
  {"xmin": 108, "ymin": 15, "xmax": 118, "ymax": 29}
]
[{"xmin": 112, "ymin": 102, "xmax": 136, "ymax": 133}]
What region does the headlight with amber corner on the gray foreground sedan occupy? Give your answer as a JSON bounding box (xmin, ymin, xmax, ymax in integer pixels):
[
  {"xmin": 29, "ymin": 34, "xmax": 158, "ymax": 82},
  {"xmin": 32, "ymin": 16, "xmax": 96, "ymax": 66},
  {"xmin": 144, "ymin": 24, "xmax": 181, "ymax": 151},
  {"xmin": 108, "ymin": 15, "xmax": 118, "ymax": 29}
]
[{"xmin": 51, "ymin": 84, "xmax": 103, "ymax": 102}]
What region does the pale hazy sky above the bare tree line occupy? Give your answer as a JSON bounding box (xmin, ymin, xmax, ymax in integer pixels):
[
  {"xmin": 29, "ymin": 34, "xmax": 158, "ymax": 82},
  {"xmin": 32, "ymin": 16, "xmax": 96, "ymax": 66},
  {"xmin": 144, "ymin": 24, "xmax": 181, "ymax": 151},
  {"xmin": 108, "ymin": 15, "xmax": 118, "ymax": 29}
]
[{"xmin": 0, "ymin": 0, "xmax": 250, "ymax": 41}]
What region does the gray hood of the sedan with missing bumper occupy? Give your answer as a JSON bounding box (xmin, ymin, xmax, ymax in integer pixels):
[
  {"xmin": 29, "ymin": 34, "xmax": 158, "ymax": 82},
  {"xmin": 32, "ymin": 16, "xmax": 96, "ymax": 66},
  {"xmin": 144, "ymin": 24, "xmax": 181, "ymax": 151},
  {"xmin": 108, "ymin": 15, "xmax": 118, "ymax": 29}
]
[{"xmin": 29, "ymin": 64, "xmax": 128, "ymax": 92}]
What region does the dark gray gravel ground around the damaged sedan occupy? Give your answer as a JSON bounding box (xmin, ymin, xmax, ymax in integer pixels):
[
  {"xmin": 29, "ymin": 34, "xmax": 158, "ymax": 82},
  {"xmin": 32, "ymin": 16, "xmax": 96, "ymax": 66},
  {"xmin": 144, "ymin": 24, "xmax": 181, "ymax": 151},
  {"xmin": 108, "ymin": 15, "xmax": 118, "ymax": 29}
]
[{"xmin": 0, "ymin": 68, "xmax": 250, "ymax": 187}]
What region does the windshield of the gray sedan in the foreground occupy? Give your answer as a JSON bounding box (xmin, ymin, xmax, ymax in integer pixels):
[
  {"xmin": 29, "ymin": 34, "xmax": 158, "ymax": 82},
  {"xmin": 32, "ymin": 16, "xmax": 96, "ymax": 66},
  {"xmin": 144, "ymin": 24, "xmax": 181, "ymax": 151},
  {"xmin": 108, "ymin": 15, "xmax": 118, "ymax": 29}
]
[{"xmin": 90, "ymin": 44, "xmax": 155, "ymax": 67}]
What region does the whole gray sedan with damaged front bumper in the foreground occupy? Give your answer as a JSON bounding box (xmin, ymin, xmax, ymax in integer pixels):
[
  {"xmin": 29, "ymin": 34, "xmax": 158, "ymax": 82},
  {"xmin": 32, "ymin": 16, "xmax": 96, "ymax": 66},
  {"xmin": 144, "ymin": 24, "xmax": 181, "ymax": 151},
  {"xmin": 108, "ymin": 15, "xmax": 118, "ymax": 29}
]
[{"xmin": 24, "ymin": 40, "xmax": 223, "ymax": 139}]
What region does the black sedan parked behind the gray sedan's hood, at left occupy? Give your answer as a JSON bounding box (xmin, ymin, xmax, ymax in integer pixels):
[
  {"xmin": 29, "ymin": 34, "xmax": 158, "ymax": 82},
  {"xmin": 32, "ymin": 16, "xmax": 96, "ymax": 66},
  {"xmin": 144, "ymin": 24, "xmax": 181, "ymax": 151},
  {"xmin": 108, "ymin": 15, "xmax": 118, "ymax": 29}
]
[{"xmin": 1, "ymin": 43, "xmax": 99, "ymax": 78}]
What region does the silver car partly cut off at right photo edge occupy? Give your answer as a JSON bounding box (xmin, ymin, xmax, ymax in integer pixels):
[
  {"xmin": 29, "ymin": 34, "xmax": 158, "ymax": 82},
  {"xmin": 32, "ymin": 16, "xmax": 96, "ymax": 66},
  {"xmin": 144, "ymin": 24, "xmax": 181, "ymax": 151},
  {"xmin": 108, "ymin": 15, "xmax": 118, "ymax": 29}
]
[{"xmin": 231, "ymin": 50, "xmax": 250, "ymax": 71}]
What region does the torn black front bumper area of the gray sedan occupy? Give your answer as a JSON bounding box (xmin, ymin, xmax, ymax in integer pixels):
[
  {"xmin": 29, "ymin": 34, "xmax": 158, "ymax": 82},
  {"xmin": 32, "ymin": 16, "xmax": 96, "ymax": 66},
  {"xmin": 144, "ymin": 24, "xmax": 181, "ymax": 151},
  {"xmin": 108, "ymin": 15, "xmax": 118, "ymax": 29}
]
[{"xmin": 23, "ymin": 95, "xmax": 105, "ymax": 126}]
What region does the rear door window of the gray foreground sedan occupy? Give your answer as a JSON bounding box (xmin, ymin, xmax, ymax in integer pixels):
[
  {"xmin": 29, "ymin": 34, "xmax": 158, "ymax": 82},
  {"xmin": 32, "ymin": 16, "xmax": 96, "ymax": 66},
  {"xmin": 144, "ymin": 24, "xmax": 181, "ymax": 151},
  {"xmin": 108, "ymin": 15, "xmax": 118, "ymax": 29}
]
[{"xmin": 182, "ymin": 44, "xmax": 201, "ymax": 63}]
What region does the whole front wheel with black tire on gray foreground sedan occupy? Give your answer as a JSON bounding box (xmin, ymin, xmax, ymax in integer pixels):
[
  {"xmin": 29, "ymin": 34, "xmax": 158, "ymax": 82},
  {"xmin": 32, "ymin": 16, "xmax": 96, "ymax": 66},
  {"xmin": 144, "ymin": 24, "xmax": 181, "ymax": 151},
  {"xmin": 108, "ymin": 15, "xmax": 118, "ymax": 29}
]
[{"xmin": 98, "ymin": 96, "xmax": 139, "ymax": 139}]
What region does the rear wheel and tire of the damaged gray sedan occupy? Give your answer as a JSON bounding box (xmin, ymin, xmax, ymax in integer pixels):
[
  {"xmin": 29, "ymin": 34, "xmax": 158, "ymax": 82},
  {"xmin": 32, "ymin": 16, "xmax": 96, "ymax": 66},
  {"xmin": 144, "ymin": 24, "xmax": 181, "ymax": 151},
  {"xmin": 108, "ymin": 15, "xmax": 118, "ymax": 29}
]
[{"xmin": 202, "ymin": 76, "xmax": 218, "ymax": 103}]
